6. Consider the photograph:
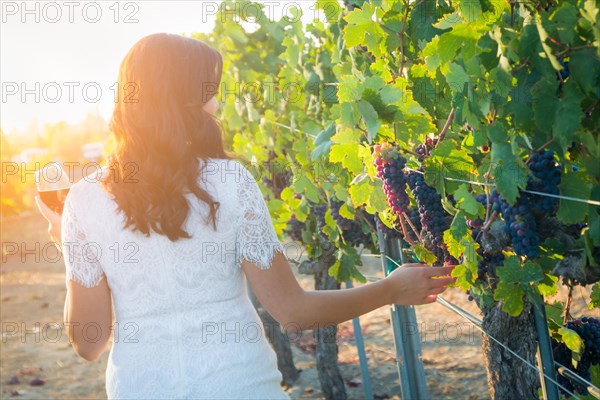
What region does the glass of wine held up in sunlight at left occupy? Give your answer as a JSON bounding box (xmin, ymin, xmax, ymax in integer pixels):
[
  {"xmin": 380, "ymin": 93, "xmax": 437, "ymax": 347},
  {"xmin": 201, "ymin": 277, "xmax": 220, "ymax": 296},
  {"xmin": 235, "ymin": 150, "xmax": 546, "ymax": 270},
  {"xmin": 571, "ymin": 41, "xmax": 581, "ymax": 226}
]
[{"xmin": 35, "ymin": 162, "xmax": 71, "ymax": 214}]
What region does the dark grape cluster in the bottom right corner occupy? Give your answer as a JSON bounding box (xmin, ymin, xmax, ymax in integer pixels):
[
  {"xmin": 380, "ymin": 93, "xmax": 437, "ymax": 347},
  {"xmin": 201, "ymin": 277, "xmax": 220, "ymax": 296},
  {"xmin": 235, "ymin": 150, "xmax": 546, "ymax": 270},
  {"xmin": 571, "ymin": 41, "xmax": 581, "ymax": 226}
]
[{"xmin": 552, "ymin": 317, "xmax": 600, "ymax": 395}]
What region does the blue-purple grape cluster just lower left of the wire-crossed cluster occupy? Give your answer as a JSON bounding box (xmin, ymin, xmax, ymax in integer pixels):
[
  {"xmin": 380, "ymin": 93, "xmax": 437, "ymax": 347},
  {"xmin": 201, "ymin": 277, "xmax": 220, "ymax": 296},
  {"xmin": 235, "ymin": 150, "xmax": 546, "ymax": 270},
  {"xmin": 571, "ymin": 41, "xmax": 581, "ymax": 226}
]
[{"xmin": 490, "ymin": 189, "xmax": 540, "ymax": 258}]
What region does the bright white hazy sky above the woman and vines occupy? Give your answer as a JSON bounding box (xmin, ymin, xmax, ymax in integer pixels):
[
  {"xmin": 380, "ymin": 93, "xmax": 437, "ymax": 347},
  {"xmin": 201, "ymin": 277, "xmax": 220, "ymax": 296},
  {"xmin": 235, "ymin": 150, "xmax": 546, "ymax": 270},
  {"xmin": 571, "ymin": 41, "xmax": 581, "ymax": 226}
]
[{"xmin": 0, "ymin": 0, "xmax": 326, "ymax": 135}]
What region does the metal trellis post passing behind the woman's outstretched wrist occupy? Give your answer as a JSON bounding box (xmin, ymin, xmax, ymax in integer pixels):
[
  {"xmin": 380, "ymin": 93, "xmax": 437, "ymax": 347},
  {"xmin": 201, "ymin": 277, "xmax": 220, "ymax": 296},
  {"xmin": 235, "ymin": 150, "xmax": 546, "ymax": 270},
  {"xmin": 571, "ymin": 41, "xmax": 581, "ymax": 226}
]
[{"xmin": 377, "ymin": 228, "xmax": 429, "ymax": 400}]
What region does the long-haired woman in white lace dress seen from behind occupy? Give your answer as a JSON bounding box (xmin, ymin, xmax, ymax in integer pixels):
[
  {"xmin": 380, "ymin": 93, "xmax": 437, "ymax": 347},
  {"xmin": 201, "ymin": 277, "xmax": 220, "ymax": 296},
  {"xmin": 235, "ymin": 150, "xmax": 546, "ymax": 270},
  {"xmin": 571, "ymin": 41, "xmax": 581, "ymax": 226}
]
[{"xmin": 36, "ymin": 33, "xmax": 454, "ymax": 399}]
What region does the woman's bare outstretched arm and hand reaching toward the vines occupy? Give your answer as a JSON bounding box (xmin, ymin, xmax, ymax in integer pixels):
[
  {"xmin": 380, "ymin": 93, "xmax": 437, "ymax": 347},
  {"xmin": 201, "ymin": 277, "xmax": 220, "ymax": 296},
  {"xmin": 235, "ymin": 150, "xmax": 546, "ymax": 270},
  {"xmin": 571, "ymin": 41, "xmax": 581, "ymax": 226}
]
[{"xmin": 242, "ymin": 253, "xmax": 455, "ymax": 330}]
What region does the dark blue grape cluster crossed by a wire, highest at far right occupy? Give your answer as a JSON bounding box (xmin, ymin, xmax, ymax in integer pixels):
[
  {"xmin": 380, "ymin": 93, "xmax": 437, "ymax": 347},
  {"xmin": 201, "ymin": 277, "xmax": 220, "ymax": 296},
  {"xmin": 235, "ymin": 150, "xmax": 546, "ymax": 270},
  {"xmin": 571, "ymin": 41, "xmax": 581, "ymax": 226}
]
[{"xmin": 527, "ymin": 150, "xmax": 561, "ymax": 215}]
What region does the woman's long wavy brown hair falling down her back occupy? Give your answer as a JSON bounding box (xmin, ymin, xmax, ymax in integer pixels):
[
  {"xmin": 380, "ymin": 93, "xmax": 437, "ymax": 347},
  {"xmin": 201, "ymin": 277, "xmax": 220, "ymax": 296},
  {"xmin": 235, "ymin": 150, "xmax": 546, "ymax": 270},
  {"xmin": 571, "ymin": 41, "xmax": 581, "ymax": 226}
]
[{"xmin": 103, "ymin": 33, "xmax": 231, "ymax": 241}]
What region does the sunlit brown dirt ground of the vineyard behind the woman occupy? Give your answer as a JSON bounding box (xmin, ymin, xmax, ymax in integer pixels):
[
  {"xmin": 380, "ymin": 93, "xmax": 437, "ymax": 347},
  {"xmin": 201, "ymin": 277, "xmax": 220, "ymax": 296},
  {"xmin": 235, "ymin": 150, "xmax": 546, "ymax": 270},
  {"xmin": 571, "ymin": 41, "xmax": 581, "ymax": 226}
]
[{"xmin": 0, "ymin": 214, "xmax": 590, "ymax": 400}]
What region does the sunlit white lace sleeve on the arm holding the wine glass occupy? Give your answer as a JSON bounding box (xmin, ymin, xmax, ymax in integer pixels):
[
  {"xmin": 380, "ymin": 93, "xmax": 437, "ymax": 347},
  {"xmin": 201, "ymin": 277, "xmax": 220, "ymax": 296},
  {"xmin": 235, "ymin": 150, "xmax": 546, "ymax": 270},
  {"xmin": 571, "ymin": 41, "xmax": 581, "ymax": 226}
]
[{"xmin": 61, "ymin": 192, "xmax": 103, "ymax": 288}]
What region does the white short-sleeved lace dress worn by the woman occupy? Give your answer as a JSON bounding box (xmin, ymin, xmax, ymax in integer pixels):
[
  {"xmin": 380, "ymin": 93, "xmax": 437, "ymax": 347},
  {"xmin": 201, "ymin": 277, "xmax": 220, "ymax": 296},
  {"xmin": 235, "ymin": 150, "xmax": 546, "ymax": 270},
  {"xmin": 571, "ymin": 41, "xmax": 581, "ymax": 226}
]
[{"xmin": 62, "ymin": 159, "xmax": 289, "ymax": 400}]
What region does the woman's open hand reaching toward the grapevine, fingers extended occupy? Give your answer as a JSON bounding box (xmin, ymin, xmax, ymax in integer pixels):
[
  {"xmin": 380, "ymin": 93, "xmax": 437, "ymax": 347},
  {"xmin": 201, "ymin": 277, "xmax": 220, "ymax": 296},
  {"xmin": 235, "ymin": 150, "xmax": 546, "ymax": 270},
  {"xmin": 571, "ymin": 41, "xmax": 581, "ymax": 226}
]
[{"xmin": 385, "ymin": 264, "xmax": 456, "ymax": 305}]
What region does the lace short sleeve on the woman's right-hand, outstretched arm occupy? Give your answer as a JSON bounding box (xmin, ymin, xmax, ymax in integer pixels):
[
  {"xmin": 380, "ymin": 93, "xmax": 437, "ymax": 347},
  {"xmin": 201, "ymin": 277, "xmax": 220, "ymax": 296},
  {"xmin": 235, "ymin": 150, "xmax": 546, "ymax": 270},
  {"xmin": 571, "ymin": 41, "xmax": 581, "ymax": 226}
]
[{"xmin": 236, "ymin": 167, "xmax": 284, "ymax": 269}]
